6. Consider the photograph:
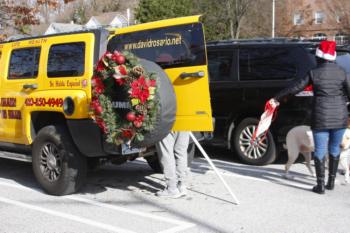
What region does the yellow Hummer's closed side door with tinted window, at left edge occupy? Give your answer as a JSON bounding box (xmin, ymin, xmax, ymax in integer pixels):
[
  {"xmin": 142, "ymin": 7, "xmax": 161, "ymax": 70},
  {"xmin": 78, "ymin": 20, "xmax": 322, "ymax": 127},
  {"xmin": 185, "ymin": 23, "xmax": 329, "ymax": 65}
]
[{"xmin": 0, "ymin": 40, "xmax": 42, "ymax": 144}]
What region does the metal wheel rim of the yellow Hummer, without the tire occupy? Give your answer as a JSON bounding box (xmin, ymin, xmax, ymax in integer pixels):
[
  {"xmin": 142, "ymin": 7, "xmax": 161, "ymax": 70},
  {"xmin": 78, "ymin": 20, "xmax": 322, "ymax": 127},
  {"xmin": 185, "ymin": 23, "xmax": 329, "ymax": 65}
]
[{"xmin": 40, "ymin": 143, "xmax": 62, "ymax": 182}]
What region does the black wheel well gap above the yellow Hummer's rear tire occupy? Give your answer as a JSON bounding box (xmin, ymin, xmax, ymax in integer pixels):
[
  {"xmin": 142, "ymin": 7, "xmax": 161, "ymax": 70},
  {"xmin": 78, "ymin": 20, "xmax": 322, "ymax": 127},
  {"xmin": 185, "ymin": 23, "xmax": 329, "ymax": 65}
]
[{"xmin": 31, "ymin": 112, "xmax": 66, "ymax": 139}]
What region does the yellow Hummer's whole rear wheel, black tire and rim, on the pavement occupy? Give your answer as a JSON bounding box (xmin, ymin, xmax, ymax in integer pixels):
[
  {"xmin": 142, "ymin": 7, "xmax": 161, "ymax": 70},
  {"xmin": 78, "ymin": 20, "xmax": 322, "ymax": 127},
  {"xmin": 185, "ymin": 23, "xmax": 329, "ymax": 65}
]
[{"xmin": 32, "ymin": 125, "xmax": 87, "ymax": 196}]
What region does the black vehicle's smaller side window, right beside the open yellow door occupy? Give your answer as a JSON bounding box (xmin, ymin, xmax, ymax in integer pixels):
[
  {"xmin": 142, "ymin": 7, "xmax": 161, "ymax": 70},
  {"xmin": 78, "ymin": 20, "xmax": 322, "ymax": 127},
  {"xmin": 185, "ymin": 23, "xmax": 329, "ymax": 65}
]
[{"xmin": 208, "ymin": 51, "xmax": 232, "ymax": 81}]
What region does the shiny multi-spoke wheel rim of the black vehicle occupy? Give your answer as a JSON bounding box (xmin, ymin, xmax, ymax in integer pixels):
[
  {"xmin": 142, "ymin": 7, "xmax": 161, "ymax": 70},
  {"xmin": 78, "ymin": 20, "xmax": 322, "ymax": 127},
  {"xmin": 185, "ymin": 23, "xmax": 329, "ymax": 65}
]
[{"xmin": 239, "ymin": 125, "xmax": 268, "ymax": 159}]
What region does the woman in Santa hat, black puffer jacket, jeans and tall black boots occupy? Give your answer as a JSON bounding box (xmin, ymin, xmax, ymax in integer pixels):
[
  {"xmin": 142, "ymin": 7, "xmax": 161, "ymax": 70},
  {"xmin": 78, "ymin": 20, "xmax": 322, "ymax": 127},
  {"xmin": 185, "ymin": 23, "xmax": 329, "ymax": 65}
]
[{"xmin": 269, "ymin": 41, "xmax": 350, "ymax": 194}]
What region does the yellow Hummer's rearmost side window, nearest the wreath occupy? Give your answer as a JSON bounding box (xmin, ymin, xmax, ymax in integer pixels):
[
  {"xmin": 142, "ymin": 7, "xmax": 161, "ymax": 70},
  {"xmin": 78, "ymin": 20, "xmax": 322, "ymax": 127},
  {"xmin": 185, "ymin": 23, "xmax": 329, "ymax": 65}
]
[{"xmin": 47, "ymin": 42, "xmax": 85, "ymax": 77}]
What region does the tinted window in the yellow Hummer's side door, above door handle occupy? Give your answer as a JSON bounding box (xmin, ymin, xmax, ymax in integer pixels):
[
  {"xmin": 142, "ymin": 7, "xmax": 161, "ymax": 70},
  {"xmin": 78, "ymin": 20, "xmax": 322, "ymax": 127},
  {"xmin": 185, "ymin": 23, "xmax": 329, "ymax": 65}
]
[{"xmin": 8, "ymin": 48, "xmax": 40, "ymax": 79}]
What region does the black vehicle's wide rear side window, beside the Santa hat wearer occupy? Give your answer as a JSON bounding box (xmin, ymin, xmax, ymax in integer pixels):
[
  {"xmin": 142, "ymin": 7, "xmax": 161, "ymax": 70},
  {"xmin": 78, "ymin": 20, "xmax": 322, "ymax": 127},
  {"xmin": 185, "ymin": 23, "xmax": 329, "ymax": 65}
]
[{"xmin": 239, "ymin": 48, "xmax": 297, "ymax": 80}]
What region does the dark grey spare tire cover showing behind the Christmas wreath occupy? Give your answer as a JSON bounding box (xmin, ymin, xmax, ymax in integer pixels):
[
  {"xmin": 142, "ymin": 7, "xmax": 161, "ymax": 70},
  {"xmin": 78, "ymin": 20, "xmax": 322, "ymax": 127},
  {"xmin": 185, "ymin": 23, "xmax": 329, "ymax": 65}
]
[{"xmin": 131, "ymin": 59, "xmax": 176, "ymax": 147}]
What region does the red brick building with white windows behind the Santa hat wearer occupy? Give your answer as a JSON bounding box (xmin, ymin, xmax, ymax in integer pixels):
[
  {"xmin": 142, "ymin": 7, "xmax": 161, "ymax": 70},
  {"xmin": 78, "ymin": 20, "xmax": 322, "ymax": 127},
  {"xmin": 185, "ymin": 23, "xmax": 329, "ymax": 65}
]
[{"xmin": 276, "ymin": 0, "xmax": 350, "ymax": 44}]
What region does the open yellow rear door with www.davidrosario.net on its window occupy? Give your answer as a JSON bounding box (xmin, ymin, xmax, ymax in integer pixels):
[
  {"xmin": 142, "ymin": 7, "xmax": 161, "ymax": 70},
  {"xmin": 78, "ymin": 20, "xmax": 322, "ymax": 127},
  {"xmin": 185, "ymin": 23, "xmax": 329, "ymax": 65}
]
[{"xmin": 108, "ymin": 16, "xmax": 213, "ymax": 131}]
